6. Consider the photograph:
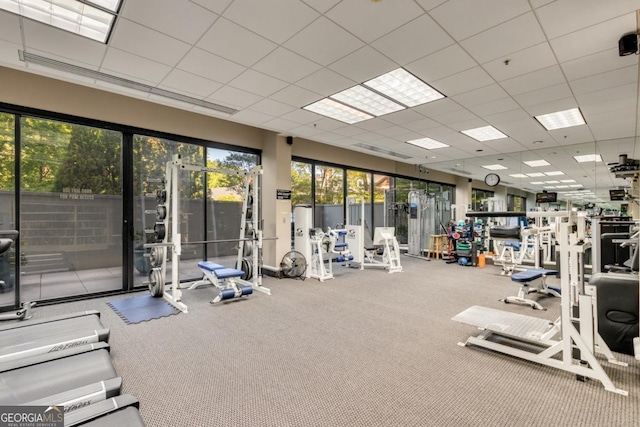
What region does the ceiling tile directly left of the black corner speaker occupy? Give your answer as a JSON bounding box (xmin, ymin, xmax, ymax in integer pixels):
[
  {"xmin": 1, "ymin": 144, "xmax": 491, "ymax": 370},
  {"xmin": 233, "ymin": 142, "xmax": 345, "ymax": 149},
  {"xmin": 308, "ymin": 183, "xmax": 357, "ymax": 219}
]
[{"xmin": 550, "ymin": 13, "xmax": 636, "ymax": 62}]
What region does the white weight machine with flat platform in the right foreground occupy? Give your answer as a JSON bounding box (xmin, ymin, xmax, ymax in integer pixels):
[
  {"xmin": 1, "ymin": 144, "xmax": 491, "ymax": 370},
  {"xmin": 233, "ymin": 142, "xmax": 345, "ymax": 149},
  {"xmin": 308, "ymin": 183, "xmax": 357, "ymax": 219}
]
[{"xmin": 453, "ymin": 207, "xmax": 628, "ymax": 396}]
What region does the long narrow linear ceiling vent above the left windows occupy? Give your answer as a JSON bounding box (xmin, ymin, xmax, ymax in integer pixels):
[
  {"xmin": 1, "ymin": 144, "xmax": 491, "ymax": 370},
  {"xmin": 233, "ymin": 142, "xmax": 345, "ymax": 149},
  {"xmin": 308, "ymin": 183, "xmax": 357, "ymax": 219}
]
[{"xmin": 18, "ymin": 50, "xmax": 238, "ymax": 115}]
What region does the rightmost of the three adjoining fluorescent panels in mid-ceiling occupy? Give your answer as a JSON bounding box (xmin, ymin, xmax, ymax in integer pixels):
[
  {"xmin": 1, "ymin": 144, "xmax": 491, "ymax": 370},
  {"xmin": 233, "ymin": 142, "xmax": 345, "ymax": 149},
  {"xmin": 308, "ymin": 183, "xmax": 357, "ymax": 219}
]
[{"xmin": 363, "ymin": 68, "xmax": 444, "ymax": 107}]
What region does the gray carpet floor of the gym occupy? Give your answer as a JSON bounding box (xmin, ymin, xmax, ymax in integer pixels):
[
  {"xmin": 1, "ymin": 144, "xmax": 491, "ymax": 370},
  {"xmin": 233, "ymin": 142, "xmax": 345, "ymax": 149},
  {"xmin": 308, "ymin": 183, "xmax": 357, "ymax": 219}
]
[{"xmin": 35, "ymin": 256, "xmax": 640, "ymax": 427}]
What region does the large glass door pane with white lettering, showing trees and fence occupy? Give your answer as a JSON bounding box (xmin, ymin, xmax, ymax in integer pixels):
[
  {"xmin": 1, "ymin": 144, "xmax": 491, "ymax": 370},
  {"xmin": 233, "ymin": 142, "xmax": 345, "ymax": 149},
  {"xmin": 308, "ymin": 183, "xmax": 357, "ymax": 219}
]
[{"xmin": 20, "ymin": 117, "xmax": 122, "ymax": 301}]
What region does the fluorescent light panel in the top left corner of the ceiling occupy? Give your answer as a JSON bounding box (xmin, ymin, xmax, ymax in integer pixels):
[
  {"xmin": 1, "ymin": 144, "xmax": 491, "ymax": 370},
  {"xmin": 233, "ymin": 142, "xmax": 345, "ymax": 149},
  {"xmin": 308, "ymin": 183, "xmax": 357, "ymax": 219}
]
[{"xmin": 0, "ymin": 0, "xmax": 120, "ymax": 43}]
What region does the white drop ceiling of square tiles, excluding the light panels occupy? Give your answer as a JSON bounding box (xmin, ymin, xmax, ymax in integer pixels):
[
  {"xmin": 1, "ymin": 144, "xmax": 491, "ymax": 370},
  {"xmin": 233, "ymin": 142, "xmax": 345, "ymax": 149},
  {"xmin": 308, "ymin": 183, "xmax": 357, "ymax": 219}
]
[{"xmin": 0, "ymin": 0, "xmax": 640, "ymax": 205}]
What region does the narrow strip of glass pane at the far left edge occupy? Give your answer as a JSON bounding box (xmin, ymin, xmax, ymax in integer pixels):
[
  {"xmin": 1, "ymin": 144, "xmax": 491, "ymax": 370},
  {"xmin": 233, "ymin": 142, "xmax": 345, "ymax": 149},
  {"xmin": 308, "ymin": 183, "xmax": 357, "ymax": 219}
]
[{"xmin": 0, "ymin": 114, "xmax": 19, "ymax": 307}]
